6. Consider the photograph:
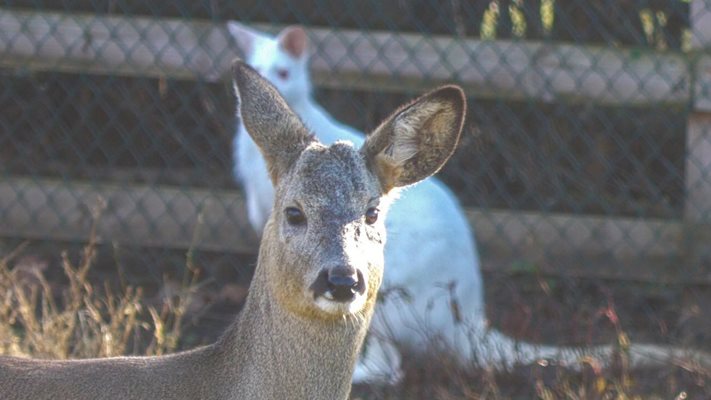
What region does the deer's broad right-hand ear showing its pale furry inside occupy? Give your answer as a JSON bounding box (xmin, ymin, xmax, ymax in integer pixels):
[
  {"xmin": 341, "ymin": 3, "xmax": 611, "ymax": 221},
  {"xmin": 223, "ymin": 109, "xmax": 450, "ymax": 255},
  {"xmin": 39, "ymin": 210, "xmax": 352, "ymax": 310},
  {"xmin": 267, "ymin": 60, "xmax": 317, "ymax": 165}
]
[{"xmin": 361, "ymin": 86, "xmax": 466, "ymax": 193}]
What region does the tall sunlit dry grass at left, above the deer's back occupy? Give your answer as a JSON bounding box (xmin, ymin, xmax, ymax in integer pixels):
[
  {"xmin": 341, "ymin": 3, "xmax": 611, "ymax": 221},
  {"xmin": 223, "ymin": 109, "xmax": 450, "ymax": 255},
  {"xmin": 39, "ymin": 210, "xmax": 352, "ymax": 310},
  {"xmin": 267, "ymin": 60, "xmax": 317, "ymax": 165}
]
[{"xmin": 0, "ymin": 220, "xmax": 197, "ymax": 359}]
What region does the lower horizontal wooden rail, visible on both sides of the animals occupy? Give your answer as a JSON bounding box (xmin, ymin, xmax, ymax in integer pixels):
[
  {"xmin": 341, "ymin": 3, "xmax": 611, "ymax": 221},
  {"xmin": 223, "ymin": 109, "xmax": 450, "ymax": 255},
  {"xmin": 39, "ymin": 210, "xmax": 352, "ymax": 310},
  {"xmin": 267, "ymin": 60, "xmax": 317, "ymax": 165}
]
[{"xmin": 0, "ymin": 177, "xmax": 683, "ymax": 261}]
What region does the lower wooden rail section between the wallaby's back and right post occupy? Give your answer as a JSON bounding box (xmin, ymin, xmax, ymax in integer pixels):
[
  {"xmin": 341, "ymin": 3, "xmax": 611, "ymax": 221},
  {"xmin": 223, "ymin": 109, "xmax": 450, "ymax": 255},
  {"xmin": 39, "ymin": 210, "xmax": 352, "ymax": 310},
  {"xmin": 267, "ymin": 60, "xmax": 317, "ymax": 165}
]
[{"xmin": 467, "ymin": 209, "xmax": 684, "ymax": 263}]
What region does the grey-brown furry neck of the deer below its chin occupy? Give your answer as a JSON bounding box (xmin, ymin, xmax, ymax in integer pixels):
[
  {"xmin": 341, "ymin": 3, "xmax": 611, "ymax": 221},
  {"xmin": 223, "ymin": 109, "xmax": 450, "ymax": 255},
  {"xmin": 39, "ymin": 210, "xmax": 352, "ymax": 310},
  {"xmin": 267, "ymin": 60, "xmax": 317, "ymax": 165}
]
[{"xmin": 216, "ymin": 256, "xmax": 370, "ymax": 400}]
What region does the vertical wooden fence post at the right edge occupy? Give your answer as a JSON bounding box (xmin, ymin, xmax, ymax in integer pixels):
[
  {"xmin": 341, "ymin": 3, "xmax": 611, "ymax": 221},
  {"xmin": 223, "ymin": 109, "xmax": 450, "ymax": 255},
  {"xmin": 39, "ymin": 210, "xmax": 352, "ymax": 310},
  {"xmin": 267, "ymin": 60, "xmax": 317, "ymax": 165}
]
[{"xmin": 684, "ymin": 0, "xmax": 711, "ymax": 267}]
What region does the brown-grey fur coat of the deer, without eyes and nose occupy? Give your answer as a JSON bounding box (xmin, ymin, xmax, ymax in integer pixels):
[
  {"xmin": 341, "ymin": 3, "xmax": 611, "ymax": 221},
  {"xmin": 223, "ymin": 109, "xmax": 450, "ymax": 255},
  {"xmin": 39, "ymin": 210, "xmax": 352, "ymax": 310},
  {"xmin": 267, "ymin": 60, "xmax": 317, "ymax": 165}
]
[{"xmin": 0, "ymin": 62, "xmax": 465, "ymax": 400}]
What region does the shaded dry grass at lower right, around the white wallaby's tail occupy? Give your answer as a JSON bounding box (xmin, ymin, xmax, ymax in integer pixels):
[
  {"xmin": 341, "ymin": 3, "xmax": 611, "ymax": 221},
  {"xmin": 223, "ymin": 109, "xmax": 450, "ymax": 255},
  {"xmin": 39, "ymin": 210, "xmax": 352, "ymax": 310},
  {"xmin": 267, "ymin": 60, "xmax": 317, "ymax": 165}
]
[{"xmin": 352, "ymin": 290, "xmax": 711, "ymax": 400}]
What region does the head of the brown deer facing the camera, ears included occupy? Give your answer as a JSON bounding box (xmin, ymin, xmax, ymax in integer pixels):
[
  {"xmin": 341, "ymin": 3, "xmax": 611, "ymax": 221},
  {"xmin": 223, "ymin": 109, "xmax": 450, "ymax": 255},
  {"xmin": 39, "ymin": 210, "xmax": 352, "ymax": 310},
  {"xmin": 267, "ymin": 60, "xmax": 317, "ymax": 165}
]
[{"xmin": 233, "ymin": 61, "xmax": 466, "ymax": 319}]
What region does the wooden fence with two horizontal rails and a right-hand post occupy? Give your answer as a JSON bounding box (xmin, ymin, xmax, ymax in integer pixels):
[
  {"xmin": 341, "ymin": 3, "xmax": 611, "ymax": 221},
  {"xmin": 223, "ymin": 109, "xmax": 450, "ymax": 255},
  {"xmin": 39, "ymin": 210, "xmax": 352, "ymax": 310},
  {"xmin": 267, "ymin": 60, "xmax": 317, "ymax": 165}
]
[{"xmin": 0, "ymin": 4, "xmax": 711, "ymax": 281}]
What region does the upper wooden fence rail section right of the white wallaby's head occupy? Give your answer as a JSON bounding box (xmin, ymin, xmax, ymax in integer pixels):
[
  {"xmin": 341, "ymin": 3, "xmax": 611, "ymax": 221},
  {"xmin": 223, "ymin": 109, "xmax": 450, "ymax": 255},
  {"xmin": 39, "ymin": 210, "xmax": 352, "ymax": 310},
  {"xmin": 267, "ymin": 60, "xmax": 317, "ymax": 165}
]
[{"xmin": 311, "ymin": 30, "xmax": 690, "ymax": 105}]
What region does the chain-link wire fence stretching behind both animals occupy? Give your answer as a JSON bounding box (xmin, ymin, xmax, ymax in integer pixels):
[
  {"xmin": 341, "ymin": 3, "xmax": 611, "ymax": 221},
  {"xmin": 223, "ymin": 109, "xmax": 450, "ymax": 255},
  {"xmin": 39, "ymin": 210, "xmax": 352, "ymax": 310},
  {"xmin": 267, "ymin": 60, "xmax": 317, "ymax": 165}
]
[{"xmin": 0, "ymin": 0, "xmax": 711, "ymax": 394}]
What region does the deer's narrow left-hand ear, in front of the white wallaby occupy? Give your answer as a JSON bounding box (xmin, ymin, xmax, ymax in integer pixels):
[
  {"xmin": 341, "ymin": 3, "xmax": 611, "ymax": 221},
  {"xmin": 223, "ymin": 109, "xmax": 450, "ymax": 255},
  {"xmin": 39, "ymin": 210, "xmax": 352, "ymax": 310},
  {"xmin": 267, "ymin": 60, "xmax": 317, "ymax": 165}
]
[{"xmin": 232, "ymin": 60, "xmax": 316, "ymax": 185}]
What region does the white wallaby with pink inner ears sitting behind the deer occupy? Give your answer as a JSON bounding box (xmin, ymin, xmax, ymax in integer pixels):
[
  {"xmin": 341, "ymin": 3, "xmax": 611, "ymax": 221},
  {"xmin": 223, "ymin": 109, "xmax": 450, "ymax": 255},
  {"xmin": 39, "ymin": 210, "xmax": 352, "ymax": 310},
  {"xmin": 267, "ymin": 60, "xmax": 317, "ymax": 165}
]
[{"xmin": 228, "ymin": 21, "xmax": 711, "ymax": 382}]
